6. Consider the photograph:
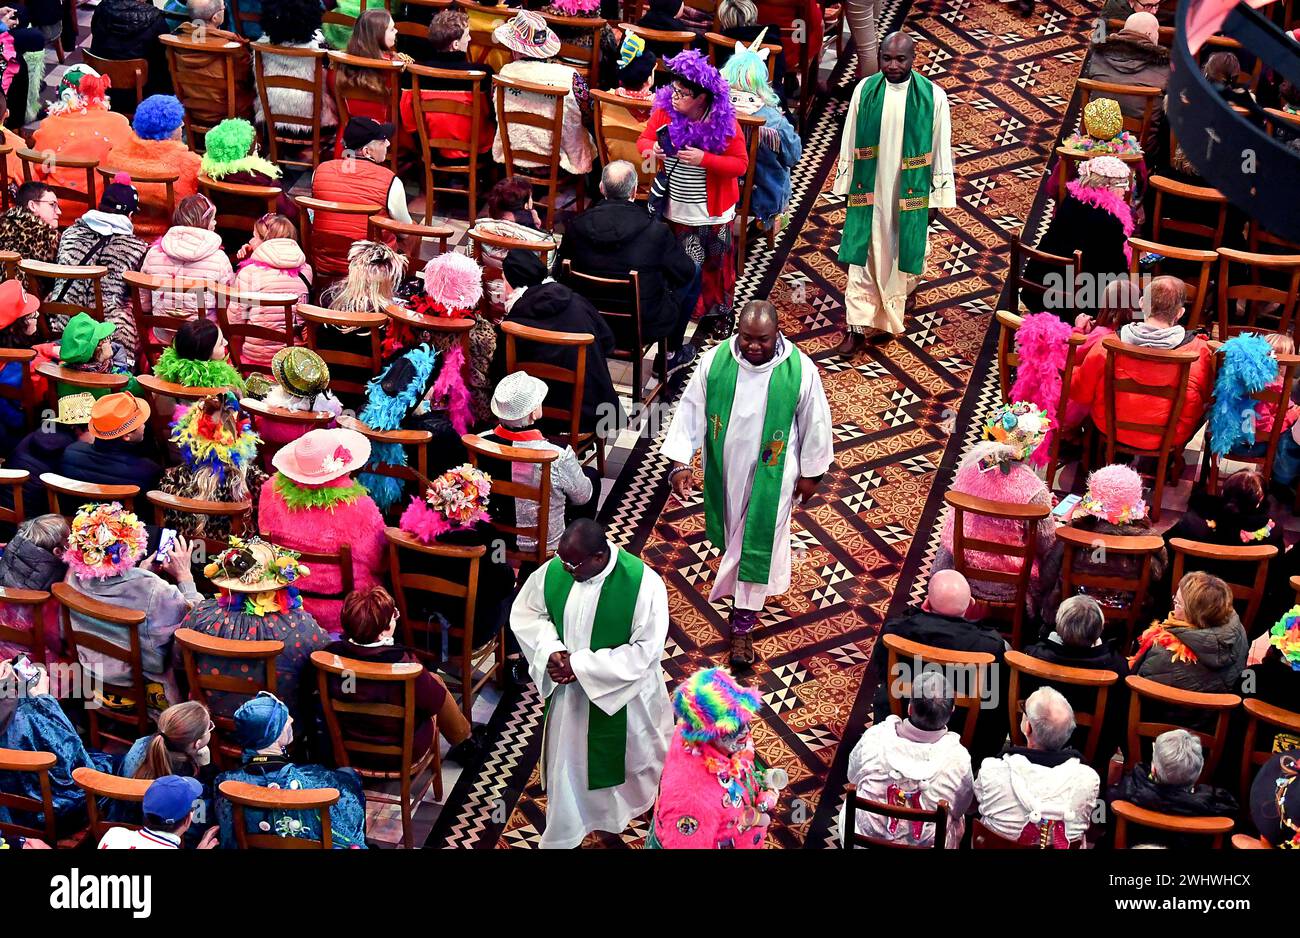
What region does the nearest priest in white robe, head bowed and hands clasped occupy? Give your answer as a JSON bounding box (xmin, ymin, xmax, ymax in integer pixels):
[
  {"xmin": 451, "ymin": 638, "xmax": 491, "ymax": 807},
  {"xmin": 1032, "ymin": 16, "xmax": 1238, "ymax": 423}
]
[{"xmin": 510, "ymin": 518, "xmax": 672, "ymax": 850}]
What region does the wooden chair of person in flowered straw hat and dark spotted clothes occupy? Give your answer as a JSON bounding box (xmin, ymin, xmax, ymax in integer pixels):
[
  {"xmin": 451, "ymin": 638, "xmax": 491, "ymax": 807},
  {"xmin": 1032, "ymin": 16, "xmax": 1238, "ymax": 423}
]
[{"xmin": 174, "ymin": 629, "xmax": 285, "ymax": 768}]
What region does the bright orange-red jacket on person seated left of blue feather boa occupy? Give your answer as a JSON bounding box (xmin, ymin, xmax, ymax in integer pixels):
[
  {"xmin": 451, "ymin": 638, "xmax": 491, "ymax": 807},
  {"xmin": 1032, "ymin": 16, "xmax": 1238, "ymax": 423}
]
[{"xmin": 1070, "ymin": 335, "xmax": 1214, "ymax": 450}]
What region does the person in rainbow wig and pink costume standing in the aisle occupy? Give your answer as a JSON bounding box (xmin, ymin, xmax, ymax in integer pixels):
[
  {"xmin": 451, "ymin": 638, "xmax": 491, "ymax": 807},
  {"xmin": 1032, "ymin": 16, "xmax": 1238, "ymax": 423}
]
[{"xmin": 646, "ymin": 668, "xmax": 777, "ymax": 850}]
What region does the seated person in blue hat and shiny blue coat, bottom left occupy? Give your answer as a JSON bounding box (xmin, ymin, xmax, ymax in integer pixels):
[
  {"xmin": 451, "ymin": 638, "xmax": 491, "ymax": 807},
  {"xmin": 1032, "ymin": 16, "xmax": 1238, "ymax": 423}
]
[{"xmin": 213, "ymin": 691, "xmax": 365, "ymax": 850}]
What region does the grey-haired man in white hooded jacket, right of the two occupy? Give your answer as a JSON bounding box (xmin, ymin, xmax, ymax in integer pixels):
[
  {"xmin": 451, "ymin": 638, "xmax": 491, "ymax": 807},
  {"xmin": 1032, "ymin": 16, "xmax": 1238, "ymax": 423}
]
[{"xmin": 975, "ymin": 687, "xmax": 1101, "ymax": 850}]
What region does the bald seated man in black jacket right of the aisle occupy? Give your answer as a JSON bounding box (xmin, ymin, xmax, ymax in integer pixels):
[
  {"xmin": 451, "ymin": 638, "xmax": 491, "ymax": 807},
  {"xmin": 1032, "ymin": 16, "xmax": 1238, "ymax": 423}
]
[{"xmin": 870, "ymin": 570, "xmax": 1006, "ymax": 757}]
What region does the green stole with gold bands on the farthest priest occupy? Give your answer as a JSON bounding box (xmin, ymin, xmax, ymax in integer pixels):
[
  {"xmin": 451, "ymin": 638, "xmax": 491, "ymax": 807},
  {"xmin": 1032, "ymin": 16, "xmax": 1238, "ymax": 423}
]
[{"xmin": 840, "ymin": 71, "xmax": 935, "ymax": 274}]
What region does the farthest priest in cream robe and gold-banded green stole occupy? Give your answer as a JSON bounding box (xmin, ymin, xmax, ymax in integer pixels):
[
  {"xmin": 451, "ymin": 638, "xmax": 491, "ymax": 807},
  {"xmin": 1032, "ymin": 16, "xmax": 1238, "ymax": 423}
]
[{"xmin": 833, "ymin": 32, "xmax": 957, "ymax": 357}]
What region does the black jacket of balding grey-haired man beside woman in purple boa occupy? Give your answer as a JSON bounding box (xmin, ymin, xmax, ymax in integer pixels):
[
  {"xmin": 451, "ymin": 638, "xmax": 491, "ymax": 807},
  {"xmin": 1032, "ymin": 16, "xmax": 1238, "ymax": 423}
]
[{"xmin": 555, "ymin": 201, "xmax": 696, "ymax": 347}]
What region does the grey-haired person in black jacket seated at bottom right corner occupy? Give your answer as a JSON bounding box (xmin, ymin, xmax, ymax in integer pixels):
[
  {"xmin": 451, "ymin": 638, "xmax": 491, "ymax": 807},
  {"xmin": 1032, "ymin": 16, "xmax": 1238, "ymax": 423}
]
[{"xmin": 1106, "ymin": 729, "xmax": 1236, "ymax": 848}]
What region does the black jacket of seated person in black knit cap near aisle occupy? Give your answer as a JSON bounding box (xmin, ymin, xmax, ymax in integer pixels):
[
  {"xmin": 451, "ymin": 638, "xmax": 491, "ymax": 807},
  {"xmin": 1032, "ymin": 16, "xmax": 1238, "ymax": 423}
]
[{"xmin": 493, "ymin": 283, "xmax": 620, "ymax": 430}]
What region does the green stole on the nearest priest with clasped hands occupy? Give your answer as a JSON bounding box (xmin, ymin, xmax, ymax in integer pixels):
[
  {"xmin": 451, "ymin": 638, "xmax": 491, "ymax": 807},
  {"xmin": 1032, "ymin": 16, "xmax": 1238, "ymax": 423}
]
[{"xmin": 542, "ymin": 548, "xmax": 646, "ymax": 791}]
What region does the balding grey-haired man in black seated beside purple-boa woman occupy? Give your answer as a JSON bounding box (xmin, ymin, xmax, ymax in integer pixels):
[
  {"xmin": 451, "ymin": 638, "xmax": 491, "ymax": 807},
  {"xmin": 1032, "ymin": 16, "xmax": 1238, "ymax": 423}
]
[{"xmin": 554, "ymin": 160, "xmax": 699, "ymax": 375}]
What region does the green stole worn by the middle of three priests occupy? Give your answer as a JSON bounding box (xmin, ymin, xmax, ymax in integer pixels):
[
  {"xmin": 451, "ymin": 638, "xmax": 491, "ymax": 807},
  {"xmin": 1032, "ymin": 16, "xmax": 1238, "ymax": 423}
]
[{"xmin": 705, "ymin": 339, "xmax": 801, "ymax": 583}]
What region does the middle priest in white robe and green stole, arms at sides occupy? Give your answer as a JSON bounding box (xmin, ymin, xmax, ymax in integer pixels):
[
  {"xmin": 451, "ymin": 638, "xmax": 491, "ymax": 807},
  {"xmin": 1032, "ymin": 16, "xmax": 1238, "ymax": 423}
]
[{"xmin": 662, "ymin": 300, "xmax": 833, "ymax": 669}]
